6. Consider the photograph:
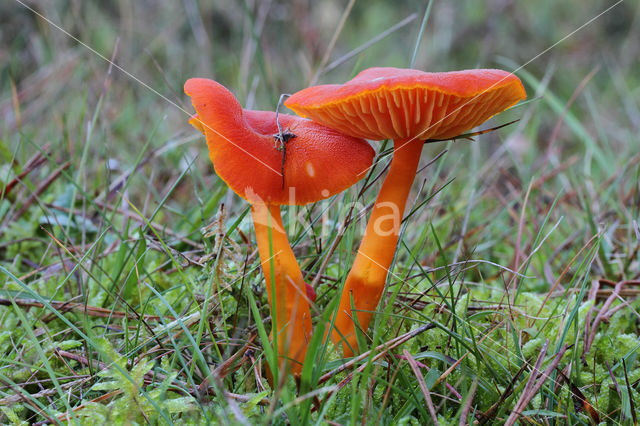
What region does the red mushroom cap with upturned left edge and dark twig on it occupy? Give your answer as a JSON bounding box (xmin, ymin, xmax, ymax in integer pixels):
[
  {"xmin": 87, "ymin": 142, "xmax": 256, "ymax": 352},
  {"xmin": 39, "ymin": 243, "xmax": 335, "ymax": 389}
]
[{"xmin": 184, "ymin": 78, "xmax": 374, "ymax": 205}]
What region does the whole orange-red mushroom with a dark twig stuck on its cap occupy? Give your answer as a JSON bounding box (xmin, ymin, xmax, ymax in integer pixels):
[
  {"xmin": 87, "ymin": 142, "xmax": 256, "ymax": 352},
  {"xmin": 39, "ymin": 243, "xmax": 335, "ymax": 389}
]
[{"xmin": 184, "ymin": 78, "xmax": 374, "ymax": 374}]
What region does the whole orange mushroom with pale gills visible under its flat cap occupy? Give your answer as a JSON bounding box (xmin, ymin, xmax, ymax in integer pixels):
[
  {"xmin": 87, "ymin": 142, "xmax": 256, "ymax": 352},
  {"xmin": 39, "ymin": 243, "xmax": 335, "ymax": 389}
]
[{"xmin": 285, "ymin": 68, "xmax": 526, "ymax": 356}]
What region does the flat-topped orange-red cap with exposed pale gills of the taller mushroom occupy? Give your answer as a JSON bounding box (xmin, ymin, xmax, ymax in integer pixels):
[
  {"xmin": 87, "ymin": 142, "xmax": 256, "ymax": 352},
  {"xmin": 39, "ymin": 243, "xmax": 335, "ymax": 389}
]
[{"xmin": 285, "ymin": 68, "xmax": 526, "ymax": 140}]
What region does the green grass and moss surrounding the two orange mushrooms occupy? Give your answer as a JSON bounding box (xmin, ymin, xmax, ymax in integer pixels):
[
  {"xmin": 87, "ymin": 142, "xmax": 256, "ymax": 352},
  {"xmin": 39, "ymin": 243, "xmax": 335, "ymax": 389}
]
[{"xmin": 0, "ymin": 0, "xmax": 640, "ymax": 424}]
